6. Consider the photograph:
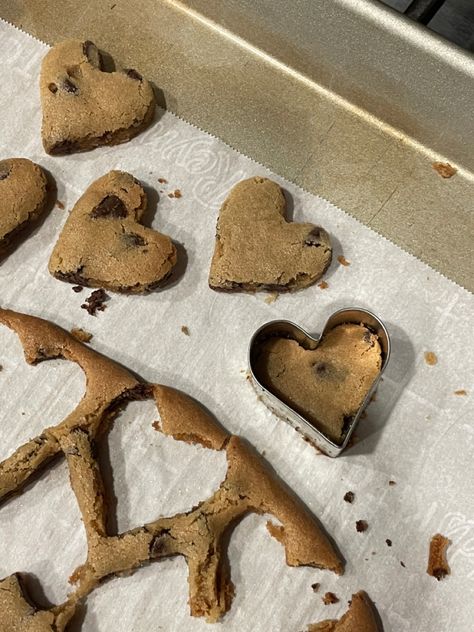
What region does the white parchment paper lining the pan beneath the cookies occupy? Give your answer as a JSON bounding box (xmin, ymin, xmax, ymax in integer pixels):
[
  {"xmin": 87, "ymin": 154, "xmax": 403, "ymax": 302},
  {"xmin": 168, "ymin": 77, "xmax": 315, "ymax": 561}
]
[{"xmin": 0, "ymin": 22, "xmax": 474, "ymax": 632}]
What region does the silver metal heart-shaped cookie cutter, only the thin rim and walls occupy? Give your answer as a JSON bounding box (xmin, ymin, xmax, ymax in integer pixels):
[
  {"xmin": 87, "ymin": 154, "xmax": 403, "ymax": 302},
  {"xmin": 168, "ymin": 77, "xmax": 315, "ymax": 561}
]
[{"xmin": 248, "ymin": 307, "xmax": 390, "ymax": 457}]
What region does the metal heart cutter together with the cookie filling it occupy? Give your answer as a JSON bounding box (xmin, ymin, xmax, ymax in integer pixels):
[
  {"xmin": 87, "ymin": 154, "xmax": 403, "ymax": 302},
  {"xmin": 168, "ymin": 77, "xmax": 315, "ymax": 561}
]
[{"xmin": 249, "ymin": 308, "xmax": 390, "ymax": 456}]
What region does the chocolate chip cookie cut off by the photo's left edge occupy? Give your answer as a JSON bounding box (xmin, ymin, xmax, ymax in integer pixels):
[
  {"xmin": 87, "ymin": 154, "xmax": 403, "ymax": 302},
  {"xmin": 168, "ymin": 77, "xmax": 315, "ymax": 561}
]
[{"xmin": 0, "ymin": 158, "xmax": 48, "ymax": 254}]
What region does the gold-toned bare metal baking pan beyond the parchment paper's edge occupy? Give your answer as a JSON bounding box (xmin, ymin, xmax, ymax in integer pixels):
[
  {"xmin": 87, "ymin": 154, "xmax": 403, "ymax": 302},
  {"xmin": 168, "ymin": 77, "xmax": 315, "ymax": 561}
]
[{"xmin": 0, "ymin": 0, "xmax": 474, "ymax": 291}]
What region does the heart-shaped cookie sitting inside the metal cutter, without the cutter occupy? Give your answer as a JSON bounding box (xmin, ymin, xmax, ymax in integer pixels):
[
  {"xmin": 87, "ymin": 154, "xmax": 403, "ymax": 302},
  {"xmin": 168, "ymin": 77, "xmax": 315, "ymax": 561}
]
[{"xmin": 254, "ymin": 323, "xmax": 382, "ymax": 443}]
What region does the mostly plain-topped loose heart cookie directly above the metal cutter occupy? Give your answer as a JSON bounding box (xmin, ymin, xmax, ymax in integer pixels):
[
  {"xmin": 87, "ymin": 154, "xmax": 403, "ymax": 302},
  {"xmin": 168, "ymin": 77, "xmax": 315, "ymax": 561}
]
[{"xmin": 209, "ymin": 177, "xmax": 332, "ymax": 292}]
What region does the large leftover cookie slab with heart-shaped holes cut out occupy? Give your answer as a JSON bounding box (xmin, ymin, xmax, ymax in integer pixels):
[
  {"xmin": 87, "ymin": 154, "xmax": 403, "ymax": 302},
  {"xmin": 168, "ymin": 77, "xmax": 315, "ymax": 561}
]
[{"xmin": 0, "ymin": 309, "xmax": 343, "ymax": 632}]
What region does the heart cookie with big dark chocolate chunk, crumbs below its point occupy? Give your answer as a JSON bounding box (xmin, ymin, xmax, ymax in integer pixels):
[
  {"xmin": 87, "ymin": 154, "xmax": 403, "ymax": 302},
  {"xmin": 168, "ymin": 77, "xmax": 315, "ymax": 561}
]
[{"xmin": 49, "ymin": 171, "xmax": 177, "ymax": 293}]
